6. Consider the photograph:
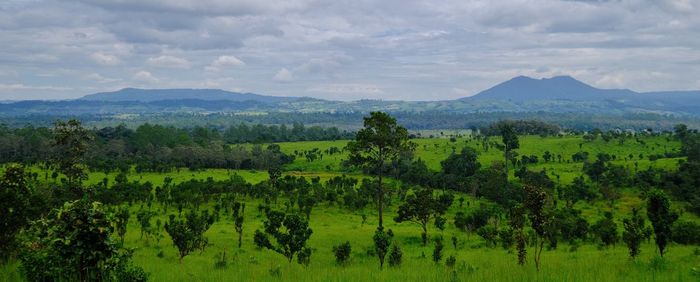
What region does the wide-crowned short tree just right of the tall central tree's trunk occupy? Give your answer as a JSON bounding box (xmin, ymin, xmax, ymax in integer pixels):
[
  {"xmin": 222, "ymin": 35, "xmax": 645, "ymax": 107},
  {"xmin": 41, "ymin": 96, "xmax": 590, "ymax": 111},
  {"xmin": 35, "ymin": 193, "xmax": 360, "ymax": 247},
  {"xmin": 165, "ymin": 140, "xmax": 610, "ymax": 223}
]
[{"xmin": 394, "ymin": 189, "xmax": 453, "ymax": 245}]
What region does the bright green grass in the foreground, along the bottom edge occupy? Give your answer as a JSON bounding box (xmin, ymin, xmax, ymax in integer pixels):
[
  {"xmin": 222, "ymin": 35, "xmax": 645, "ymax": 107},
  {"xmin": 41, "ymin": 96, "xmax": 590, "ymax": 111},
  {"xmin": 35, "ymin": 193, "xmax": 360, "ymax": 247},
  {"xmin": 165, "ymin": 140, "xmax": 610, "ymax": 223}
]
[{"xmin": 0, "ymin": 199, "xmax": 700, "ymax": 281}]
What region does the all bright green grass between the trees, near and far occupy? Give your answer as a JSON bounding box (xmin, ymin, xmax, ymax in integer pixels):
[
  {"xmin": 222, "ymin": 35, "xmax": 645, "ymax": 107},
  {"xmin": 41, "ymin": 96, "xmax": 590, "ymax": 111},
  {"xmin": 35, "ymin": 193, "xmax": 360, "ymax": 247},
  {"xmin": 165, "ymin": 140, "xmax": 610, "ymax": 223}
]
[{"xmin": 0, "ymin": 136, "xmax": 700, "ymax": 281}]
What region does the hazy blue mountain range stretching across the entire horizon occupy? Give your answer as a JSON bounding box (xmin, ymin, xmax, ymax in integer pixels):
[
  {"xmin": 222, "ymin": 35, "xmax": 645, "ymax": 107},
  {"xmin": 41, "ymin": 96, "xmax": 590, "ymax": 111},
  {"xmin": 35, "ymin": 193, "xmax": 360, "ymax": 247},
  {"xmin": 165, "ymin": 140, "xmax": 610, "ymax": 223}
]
[{"xmin": 0, "ymin": 76, "xmax": 700, "ymax": 117}]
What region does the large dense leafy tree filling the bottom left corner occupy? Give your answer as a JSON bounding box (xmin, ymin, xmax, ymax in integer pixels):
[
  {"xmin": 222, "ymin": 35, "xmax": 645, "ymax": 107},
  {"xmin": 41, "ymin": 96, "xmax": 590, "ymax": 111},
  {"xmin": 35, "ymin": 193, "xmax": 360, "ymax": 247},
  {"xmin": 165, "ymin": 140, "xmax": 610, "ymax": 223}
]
[{"xmin": 20, "ymin": 199, "xmax": 148, "ymax": 281}]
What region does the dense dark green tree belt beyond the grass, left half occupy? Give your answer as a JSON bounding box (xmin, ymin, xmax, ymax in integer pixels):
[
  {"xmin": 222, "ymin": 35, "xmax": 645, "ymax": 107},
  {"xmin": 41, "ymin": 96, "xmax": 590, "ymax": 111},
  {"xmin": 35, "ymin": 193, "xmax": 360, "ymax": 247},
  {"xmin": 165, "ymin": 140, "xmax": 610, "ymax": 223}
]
[{"xmin": 0, "ymin": 123, "xmax": 354, "ymax": 171}]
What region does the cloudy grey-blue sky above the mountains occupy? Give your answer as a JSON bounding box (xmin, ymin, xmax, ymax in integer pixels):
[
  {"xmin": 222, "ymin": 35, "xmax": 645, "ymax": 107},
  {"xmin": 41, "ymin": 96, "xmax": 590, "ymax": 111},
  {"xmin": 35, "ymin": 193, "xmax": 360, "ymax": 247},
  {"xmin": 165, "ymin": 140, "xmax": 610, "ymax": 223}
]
[{"xmin": 0, "ymin": 0, "xmax": 700, "ymax": 100}]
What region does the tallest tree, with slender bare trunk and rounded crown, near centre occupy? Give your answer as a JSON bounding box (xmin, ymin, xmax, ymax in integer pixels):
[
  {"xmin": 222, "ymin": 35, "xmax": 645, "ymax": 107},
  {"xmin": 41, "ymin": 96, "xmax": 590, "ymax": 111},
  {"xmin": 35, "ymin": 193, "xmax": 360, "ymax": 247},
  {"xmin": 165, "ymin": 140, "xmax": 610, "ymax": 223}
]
[{"xmin": 346, "ymin": 112, "xmax": 416, "ymax": 228}]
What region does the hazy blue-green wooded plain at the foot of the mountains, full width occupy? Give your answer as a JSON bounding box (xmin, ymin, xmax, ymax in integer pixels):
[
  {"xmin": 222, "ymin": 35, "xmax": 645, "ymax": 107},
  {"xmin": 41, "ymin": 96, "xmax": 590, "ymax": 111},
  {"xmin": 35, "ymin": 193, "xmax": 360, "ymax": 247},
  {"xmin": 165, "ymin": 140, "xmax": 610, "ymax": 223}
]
[{"xmin": 0, "ymin": 111, "xmax": 700, "ymax": 132}]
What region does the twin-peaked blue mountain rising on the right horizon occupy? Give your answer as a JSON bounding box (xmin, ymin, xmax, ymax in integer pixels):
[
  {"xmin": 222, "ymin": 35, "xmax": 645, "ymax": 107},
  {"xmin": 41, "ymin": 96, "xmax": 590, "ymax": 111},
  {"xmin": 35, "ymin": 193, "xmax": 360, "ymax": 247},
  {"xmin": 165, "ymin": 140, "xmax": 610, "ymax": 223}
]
[{"xmin": 463, "ymin": 76, "xmax": 636, "ymax": 102}]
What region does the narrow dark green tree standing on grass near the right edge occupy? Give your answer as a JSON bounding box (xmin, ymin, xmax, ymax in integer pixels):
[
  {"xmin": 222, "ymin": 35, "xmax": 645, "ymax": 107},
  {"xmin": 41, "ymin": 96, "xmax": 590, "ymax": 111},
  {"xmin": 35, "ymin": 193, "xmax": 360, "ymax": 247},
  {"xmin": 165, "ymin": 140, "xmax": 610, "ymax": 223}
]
[{"xmin": 647, "ymin": 190, "xmax": 678, "ymax": 257}]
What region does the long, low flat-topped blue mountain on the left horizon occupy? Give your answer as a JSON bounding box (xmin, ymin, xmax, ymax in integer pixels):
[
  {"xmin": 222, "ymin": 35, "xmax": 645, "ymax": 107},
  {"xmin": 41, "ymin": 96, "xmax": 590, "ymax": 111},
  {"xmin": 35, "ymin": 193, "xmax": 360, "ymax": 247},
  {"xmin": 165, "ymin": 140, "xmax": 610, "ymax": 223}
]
[{"xmin": 79, "ymin": 88, "xmax": 309, "ymax": 103}]
